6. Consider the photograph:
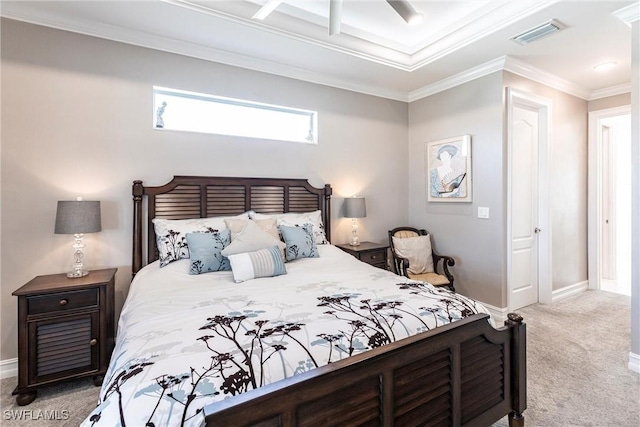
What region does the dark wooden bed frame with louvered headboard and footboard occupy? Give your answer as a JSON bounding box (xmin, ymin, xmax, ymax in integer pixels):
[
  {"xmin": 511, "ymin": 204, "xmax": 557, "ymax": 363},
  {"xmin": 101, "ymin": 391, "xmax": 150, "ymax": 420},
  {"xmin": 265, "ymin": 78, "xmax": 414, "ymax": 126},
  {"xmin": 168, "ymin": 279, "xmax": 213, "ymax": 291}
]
[{"xmin": 132, "ymin": 176, "xmax": 527, "ymax": 427}]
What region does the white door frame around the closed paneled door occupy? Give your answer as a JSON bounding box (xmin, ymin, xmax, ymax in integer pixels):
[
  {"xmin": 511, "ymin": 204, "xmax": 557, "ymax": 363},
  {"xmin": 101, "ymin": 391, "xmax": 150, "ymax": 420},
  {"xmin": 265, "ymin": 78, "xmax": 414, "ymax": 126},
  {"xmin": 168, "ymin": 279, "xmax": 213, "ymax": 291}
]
[{"xmin": 506, "ymin": 87, "xmax": 553, "ymax": 310}]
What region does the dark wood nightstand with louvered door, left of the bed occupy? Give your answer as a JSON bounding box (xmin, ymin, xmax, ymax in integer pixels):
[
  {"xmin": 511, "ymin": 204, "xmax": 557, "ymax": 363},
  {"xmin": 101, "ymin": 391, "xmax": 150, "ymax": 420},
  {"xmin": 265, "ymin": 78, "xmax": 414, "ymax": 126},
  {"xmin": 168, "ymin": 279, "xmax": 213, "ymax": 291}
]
[{"xmin": 13, "ymin": 268, "xmax": 117, "ymax": 406}]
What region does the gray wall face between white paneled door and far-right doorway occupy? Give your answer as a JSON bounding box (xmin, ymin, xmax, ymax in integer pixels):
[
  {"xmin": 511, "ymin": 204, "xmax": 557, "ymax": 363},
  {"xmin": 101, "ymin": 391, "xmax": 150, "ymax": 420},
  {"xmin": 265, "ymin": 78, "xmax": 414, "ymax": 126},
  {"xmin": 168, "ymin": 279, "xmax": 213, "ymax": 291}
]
[{"xmin": 504, "ymin": 72, "xmax": 588, "ymax": 291}]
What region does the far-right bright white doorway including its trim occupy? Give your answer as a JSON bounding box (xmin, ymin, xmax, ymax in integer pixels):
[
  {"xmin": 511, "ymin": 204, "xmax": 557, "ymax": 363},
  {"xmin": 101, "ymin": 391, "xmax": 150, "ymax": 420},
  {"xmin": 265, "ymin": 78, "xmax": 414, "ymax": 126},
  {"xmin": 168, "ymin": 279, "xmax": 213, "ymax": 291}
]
[{"xmin": 589, "ymin": 106, "xmax": 631, "ymax": 295}]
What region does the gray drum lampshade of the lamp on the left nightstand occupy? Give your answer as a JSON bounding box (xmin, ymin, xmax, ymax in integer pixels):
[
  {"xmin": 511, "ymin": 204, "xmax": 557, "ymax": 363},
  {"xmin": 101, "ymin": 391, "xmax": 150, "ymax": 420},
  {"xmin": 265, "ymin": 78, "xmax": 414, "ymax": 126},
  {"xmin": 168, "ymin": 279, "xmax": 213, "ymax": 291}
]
[{"xmin": 55, "ymin": 200, "xmax": 102, "ymax": 234}]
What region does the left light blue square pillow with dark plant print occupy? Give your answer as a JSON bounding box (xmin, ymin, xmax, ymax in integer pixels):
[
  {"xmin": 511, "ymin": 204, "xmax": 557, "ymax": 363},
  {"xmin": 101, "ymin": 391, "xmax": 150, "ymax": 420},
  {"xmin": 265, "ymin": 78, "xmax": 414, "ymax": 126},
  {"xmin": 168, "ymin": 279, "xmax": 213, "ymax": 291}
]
[{"xmin": 186, "ymin": 230, "xmax": 231, "ymax": 274}]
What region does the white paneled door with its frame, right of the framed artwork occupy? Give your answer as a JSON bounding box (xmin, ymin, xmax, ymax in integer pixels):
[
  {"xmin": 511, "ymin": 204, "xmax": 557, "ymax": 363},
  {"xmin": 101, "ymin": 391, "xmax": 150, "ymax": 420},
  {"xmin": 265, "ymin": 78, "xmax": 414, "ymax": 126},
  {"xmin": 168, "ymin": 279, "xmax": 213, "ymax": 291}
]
[{"xmin": 506, "ymin": 88, "xmax": 552, "ymax": 310}]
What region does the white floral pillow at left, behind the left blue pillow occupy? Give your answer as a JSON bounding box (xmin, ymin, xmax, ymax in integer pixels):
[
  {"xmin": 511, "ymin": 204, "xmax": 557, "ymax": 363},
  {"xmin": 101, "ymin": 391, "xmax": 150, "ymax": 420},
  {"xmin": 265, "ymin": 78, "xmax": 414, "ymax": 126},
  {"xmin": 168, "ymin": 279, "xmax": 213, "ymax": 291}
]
[{"xmin": 152, "ymin": 212, "xmax": 249, "ymax": 267}]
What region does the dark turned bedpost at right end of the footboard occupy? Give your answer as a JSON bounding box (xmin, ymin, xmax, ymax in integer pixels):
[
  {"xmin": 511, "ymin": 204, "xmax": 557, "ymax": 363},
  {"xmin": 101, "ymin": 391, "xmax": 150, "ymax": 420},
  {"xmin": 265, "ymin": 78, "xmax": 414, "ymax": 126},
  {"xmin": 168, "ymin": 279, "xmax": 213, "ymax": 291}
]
[{"xmin": 504, "ymin": 313, "xmax": 527, "ymax": 427}]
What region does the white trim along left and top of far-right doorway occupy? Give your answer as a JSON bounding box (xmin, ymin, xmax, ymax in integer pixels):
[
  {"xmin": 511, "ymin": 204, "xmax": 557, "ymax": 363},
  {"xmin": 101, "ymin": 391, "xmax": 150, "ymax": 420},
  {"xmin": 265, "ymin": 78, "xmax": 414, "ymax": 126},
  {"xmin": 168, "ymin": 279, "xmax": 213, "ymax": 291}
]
[{"xmin": 587, "ymin": 105, "xmax": 631, "ymax": 290}]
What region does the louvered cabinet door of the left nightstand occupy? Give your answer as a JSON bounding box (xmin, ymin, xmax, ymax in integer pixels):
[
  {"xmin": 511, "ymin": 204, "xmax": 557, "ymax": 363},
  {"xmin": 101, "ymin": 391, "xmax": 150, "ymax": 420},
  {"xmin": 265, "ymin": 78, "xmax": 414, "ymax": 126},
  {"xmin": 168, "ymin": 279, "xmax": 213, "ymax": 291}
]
[{"xmin": 28, "ymin": 310, "xmax": 100, "ymax": 384}]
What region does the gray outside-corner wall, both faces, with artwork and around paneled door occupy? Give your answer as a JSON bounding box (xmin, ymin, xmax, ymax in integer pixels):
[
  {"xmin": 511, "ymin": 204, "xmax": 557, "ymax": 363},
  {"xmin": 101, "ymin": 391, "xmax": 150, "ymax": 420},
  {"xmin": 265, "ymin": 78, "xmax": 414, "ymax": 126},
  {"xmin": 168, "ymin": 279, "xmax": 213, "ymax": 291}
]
[{"xmin": 409, "ymin": 72, "xmax": 587, "ymax": 307}]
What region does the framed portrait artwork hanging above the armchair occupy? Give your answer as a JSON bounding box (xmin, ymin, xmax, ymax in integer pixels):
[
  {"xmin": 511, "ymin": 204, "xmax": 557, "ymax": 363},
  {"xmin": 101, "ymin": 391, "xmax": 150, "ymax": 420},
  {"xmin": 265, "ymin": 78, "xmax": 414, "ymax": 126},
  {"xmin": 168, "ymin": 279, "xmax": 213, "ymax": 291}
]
[{"xmin": 427, "ymin": 134, "xmax": 472, "ymax": 202}]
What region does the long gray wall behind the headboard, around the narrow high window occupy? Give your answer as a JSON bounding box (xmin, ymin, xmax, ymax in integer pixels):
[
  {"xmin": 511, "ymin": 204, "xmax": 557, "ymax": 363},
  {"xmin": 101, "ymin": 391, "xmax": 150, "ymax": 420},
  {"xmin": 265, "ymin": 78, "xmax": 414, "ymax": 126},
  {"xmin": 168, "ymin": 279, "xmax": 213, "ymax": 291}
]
[{"xmin": 0, "ymin": 20, "xmax": 408, "ymax": 360}]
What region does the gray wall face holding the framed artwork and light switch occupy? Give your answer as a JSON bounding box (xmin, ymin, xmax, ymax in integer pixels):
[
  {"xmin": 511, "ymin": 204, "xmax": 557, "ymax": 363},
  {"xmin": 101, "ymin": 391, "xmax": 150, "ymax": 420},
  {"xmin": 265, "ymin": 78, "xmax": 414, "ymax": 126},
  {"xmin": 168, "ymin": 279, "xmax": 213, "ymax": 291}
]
[{"xmin": 409, "ymin": 72, "xmax": 506, "ymax": 307}]
